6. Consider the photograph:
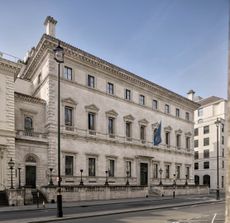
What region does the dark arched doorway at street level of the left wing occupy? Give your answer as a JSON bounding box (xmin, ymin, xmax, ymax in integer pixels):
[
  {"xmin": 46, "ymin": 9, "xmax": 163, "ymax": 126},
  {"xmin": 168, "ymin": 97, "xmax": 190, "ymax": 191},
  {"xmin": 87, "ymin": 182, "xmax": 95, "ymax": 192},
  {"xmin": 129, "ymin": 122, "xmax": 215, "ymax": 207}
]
[{"xmin": 25, "ymin": 155, "xmax": 36, "ymax": 188}]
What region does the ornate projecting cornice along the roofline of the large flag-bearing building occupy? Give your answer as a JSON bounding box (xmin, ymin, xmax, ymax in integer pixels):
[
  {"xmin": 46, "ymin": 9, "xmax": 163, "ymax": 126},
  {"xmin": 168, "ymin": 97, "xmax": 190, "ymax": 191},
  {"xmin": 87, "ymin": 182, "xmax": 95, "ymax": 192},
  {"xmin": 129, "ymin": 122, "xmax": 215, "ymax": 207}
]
[{"xmin": 23, "ymin": 34, "xmax": 200, "ymax": 110}]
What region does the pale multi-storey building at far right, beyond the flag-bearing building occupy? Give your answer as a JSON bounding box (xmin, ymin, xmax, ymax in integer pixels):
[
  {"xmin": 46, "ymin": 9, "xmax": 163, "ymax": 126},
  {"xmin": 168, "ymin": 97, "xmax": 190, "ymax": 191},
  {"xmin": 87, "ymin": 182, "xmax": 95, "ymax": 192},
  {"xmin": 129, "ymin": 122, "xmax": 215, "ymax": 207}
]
[{"xmin": 190, "ymin": 92, "xmax": 227, "ymax": 191}]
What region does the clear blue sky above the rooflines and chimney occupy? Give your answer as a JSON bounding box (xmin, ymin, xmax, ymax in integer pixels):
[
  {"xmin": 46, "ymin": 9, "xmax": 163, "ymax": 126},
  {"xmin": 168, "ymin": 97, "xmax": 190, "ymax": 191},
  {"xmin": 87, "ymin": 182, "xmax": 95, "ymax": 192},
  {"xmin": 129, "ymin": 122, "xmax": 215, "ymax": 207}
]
[{"xmin": 0, "ymin": 0, "xmax": 229, "ymax": 98}]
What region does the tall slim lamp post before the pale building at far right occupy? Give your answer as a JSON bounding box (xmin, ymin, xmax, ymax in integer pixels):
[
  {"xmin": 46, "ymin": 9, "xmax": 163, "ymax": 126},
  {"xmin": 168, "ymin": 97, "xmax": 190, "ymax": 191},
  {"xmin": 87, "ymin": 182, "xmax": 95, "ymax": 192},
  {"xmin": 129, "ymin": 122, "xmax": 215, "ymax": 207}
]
[{"xmin": 215, "ymin": 118, "xmax": 221, "ymax": 200}]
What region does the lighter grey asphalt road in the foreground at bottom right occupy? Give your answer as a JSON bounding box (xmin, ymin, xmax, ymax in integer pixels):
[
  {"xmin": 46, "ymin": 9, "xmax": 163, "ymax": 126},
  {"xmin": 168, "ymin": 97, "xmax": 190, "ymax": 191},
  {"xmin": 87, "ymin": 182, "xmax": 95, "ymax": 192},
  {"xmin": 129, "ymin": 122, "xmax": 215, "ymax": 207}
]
[{"xmin": 56, "ymin": 202, "xmax": 225, "ymax": 223}]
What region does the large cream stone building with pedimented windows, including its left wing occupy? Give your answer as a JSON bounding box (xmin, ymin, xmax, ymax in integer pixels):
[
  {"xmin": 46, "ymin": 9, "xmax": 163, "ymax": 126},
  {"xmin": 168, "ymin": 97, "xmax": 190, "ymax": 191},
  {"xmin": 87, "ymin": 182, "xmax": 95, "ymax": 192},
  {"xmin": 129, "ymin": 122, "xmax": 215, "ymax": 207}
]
[{"xmin": 0, "ymin": 17, "xmax": 199, "ymax": 193}]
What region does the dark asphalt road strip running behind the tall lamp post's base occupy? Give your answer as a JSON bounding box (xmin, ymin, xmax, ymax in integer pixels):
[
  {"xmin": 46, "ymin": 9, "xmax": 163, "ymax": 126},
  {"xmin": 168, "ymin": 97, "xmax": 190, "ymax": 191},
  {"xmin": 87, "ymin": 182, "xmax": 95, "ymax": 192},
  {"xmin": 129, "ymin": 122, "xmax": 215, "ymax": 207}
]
[{"xmin": 0, "ymin": 197, "xmax": 223, "ymax": 222}]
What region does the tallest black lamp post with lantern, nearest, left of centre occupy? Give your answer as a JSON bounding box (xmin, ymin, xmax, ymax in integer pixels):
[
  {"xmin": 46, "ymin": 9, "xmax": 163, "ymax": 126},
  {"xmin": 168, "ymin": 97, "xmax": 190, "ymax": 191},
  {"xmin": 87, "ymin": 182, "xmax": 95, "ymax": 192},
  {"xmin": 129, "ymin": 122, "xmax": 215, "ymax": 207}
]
[{"xmin": 54, "ymin": 41, "xmax": 64, "ymax": 217}]
